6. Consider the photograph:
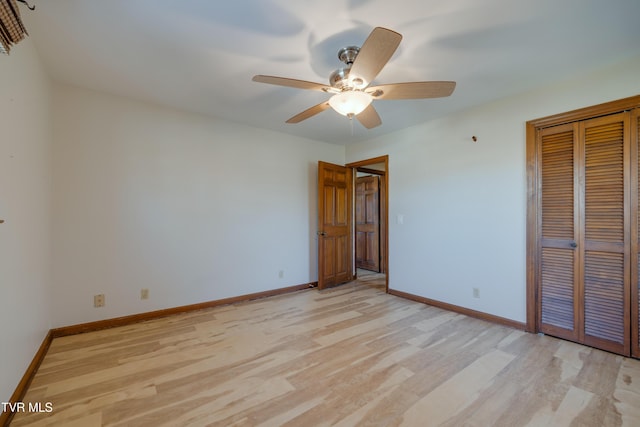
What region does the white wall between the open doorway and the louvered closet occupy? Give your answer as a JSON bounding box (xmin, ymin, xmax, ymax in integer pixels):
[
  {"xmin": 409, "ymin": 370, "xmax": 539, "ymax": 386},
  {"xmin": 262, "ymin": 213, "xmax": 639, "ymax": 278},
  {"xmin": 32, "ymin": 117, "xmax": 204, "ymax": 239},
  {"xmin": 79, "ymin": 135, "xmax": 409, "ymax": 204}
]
[{"xmin": 346, "ymin": 57, "xmax": 640, "ymax": 322}]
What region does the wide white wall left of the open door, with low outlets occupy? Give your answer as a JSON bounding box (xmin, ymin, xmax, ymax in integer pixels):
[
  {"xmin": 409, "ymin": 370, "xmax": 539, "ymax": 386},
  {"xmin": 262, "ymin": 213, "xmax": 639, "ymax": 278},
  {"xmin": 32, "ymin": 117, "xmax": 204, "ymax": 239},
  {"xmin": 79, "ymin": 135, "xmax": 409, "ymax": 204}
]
[{"xmin": 53, "ymin": 85, "xmax": 344, "ymax": 326}]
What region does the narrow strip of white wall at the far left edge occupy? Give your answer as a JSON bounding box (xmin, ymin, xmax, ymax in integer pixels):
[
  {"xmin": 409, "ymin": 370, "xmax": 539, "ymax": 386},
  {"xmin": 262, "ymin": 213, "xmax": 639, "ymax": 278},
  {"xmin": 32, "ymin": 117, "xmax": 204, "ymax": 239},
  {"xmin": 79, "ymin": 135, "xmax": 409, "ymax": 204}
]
[{"xmin": 0, "ymin": 39, "xmax": 51, "ymax": 402}]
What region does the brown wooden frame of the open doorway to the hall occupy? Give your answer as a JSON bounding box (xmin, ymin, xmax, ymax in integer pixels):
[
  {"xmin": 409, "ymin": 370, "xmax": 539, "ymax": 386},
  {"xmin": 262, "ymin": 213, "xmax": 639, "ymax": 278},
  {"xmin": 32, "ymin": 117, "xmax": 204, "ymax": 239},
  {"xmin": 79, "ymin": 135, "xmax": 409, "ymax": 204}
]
[{"xmin": 345, "ymin": 155, "xmax": 389, "ymax": 293}]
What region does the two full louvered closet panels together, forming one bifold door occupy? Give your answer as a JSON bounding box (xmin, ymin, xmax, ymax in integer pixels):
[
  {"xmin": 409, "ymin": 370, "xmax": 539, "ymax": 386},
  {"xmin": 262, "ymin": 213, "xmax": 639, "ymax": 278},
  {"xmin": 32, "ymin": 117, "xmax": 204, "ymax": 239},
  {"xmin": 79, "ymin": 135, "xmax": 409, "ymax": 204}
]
[{"xmin": 539, "ymin": 113, "xmax": 631, "ymax": 355}]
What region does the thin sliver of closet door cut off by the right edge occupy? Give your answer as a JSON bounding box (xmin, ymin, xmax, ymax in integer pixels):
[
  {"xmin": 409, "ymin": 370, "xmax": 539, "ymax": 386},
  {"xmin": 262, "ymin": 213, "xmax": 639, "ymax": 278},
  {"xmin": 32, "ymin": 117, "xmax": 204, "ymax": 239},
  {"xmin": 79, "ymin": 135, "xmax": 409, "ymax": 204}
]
[{"xmin": 631, "ymin": 109, "xmax": 640, "ymax": 358}]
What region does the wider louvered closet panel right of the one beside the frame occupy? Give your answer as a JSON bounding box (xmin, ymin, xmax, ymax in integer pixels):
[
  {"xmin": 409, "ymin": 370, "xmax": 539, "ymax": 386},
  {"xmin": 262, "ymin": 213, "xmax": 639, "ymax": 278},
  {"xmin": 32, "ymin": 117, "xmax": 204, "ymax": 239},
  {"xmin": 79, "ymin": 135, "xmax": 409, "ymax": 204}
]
[{"xmin": 578, "ymin": 113, "xmax": 631, "ymax": 355}]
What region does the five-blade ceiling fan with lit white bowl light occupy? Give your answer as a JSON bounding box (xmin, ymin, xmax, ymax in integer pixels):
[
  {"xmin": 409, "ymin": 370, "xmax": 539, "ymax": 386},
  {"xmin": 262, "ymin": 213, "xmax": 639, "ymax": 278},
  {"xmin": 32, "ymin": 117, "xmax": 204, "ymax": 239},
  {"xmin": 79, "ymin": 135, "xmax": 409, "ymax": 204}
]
[{"xmin": 252, "ymin": 27, "xmax": 456, "ymax": 129}]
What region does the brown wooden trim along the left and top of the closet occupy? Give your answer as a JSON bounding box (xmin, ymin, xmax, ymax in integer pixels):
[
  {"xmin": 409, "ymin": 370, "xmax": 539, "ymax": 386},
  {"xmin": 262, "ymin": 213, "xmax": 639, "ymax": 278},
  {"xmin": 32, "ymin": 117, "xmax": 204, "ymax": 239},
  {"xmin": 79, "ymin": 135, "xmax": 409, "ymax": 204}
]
[{"xmin": 525, "ymin": 95, "xmax": 640, "ymax": 333}]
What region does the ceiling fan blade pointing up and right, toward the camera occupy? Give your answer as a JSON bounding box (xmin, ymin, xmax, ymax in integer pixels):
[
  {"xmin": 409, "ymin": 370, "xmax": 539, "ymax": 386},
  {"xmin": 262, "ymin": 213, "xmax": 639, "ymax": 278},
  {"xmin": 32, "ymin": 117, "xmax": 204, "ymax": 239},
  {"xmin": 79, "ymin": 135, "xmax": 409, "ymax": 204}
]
[{"xmin": 349, "ymin": 27, "xmax": 402, "ymax": 85}]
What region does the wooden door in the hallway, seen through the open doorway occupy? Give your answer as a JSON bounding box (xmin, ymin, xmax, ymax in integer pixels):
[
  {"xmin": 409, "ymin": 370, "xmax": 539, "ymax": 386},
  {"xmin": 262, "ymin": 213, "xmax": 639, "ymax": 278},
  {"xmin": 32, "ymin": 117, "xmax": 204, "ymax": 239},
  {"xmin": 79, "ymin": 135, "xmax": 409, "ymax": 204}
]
[{"xmin": 355, "ymin": 175, "xmax": 380, "ymax": 273}]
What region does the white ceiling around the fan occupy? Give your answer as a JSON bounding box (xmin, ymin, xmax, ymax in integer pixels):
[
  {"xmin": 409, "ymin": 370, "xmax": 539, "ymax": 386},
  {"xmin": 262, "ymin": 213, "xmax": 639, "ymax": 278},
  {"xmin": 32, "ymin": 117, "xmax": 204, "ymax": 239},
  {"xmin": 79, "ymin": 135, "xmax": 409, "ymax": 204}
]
[{"xmin": 14, "ymin": 0, "xmax": 640, "ymax": 144}]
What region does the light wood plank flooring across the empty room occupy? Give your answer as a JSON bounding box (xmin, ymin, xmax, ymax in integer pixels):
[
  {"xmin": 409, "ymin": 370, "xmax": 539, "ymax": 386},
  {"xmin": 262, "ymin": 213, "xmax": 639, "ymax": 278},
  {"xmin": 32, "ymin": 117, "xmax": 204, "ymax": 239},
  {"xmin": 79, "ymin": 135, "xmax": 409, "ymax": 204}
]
[{"xmin": 12, "ymin": 275, "xmax": 640, "ymax": 427}]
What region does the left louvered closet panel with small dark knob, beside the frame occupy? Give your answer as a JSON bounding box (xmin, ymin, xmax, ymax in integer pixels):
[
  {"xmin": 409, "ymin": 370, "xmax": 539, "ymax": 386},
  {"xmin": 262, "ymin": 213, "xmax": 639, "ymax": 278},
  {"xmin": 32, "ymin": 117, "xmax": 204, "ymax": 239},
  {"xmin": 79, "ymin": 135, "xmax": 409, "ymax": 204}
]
[{"xmin": 538, "ymin": 124, "xmax": 581, "ymax": 341}]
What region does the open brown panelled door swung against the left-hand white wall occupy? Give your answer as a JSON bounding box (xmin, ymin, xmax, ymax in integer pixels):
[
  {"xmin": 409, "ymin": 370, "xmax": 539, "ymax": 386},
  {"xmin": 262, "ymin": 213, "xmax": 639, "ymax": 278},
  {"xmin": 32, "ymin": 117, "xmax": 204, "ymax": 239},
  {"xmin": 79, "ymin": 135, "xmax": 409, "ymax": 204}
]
[{"xmin": 318, "ymin": 162, "xmax": 353, "ymax": 289}]
